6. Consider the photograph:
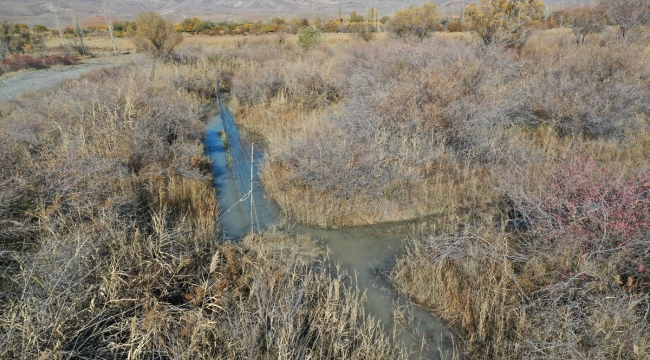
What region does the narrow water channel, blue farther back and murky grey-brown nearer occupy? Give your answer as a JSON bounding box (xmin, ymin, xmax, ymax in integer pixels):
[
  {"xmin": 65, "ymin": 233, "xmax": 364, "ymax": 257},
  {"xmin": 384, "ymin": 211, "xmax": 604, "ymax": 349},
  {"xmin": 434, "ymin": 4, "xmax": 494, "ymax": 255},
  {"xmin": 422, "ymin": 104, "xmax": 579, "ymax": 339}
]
[{"xmin": 206, "ymin": 99, "xmax": 458, "ymax": 359}]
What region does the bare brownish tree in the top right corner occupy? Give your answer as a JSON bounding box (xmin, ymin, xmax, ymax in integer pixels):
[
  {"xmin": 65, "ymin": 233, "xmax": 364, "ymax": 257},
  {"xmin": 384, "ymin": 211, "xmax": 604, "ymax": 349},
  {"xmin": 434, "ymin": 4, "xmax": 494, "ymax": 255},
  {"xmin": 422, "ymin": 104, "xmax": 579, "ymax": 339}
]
[{"xmin": 600, "ymin": 0, "xmax": 650, "ymax": 41}]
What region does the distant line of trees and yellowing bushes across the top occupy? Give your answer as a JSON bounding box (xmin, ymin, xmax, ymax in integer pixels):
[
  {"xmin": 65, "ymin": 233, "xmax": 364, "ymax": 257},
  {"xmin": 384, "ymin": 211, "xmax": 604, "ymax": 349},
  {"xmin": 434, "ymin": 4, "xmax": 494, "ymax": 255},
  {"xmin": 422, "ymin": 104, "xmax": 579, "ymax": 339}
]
[{"xmin": 0, "ymin": 0, "xmax": 650, "ymax": 66}]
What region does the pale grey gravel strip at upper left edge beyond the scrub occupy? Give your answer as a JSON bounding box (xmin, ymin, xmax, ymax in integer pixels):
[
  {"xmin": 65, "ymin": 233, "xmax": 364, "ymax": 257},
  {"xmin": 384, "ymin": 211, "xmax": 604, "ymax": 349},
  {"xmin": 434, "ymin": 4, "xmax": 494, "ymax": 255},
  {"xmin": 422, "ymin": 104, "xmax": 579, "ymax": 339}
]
[{"xmin": 0, "ymin": 54, "xmax": 140, "ymax": 102}]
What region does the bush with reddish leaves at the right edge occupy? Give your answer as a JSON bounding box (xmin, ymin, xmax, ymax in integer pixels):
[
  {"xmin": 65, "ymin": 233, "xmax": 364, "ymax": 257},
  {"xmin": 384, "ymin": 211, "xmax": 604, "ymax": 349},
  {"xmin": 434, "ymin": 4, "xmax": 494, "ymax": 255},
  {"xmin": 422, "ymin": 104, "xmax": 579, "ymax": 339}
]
[{"xmin": 515, "ymin": 151, "xmax": 650, "ymax": 287}]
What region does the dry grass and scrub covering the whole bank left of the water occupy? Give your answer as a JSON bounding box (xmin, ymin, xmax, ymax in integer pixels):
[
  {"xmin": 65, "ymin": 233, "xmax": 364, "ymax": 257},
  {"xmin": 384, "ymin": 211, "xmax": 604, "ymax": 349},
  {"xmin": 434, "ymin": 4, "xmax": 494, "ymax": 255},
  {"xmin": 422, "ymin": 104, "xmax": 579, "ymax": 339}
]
[{"xmin": 0, "ymin": 57, "xmax": 403, "ymax": 359}]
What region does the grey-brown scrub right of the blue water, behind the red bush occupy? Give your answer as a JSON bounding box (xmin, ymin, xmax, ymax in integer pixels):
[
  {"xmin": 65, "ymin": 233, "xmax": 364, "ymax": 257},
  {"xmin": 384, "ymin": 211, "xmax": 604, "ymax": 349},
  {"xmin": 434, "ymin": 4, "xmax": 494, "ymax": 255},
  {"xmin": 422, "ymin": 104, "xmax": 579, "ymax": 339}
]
[{"xmin": 221, "ymin": 30, "xmax": 648, "ymax": 227}]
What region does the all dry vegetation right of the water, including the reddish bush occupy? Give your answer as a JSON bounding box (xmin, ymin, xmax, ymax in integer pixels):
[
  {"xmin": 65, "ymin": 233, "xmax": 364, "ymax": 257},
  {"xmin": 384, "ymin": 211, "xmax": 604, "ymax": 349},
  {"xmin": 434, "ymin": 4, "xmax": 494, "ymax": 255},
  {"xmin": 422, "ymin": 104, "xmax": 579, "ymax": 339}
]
[{"xmin": 204, "ymin": 25, "xmax": 650, "ymax": 359}]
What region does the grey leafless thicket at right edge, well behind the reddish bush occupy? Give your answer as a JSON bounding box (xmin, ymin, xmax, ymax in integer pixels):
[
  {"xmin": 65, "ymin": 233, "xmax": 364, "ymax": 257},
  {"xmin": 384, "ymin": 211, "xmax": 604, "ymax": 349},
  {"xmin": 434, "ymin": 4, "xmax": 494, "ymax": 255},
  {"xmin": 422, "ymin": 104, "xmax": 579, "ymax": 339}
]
[{"xmin": 510, "ymin": 44, "xmax": 650, "ymax": 137}]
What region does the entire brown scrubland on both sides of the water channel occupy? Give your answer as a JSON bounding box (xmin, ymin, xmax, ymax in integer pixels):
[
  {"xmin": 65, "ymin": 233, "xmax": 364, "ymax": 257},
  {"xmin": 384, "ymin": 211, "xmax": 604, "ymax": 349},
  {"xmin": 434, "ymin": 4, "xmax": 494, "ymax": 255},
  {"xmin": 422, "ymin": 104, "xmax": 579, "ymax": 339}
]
[{"xmin": 0, "ymin": 2, "xmax": 650, "ymax": 359}]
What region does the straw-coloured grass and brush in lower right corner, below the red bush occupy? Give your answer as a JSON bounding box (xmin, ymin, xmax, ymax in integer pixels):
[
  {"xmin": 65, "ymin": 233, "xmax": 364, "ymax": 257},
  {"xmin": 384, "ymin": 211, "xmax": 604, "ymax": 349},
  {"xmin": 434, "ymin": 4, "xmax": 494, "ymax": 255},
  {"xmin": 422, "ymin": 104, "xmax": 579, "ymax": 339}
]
[{"xmin": 391, "ymin": 229, "xmax": 650, "ymax": 359}]
